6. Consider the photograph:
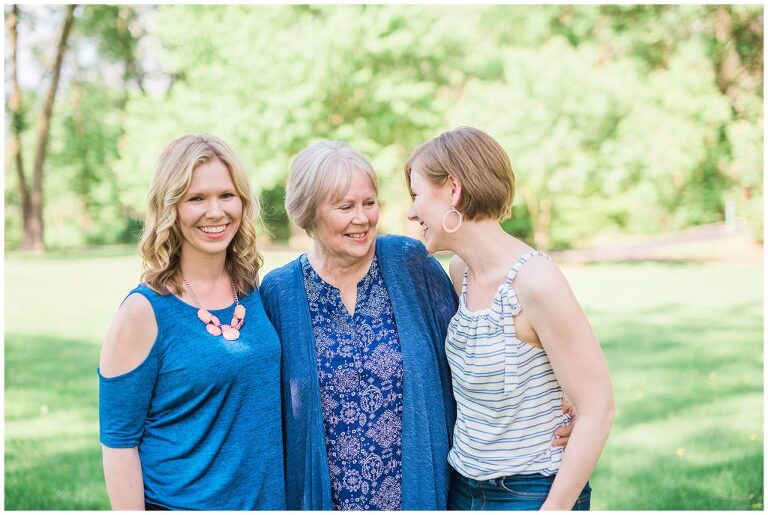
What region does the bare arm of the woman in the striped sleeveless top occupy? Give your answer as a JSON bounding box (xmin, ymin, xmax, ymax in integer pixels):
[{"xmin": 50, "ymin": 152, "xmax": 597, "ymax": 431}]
[{"xmin": 517, "ymin": 259, "xmax": 614, "ymax": 510}]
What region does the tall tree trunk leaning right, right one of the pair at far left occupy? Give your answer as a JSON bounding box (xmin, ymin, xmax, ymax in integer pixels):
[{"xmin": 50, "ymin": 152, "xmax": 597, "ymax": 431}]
[{"xmin": 21, "ymin": 5, "xmax": 76, "ymax": 251}]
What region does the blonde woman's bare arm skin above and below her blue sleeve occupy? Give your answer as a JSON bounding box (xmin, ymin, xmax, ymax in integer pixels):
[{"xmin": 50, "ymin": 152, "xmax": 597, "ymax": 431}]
[{"xmin": 99, "ymin": 294, "xmax": 157, "ymax": 510}]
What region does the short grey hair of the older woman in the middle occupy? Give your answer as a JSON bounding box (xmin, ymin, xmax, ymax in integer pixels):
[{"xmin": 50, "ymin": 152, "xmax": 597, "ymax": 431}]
[{"xmin": 285, "ymin": 140, "xmax": 379, "ymax": 234}]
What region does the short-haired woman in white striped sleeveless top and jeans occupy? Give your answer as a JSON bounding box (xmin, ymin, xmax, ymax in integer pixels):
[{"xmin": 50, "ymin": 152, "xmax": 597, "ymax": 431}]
[{"xmin": 405, "ymin": 127, "xmax": 614, "ymax": 510}]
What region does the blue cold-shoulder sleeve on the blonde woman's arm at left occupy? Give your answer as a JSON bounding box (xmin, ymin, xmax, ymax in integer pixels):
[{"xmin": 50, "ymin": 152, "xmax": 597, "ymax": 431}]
[{"xmin": 96, "ymin": 344, "xmax": 159, "ymax": 448}]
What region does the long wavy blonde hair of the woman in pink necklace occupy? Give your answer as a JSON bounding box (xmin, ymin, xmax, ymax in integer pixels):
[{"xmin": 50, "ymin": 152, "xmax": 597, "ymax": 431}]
[{"xmin": 139, "ymin": 134, "xmax": 263, "ymax": 295}]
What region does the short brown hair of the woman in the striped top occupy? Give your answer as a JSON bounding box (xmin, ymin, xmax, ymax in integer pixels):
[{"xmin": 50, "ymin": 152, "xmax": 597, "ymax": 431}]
[{"xmin": 405, "ymin": 127, "xmax": 515, "ymax": 220}]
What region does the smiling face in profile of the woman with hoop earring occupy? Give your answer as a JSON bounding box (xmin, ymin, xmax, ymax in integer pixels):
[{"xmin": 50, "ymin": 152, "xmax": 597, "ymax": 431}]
[{"xmin": 408, "ymin": 160, "xmax": 456, "ymax": 254}]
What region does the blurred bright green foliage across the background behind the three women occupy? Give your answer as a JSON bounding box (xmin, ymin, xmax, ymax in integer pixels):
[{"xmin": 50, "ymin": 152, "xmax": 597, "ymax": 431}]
[{"xmin": 5, "ymin": 5, "xmax": 763, "ymax": 248}]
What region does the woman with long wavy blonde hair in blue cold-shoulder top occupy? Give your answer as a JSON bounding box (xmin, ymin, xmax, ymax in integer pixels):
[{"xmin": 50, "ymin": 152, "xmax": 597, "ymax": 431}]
[{"xmin": 99, "ymin": 135, "xmax": 285, "ymax": 510}]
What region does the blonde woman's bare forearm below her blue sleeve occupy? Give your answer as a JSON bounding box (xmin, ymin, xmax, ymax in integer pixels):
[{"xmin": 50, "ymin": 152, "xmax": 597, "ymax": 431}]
[{"xmin": 101, "ymin": 445, "xmax": 144, "ymax": 510}]
